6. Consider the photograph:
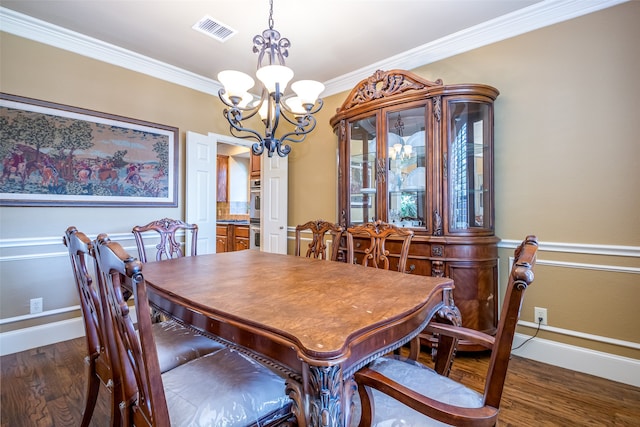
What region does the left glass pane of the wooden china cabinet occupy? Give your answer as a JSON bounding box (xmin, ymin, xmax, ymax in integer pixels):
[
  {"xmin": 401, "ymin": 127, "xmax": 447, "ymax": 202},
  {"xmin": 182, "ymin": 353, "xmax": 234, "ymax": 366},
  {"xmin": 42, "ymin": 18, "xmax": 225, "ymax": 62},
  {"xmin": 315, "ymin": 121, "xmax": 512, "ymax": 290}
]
[{"xmin": 349, "ymin": 116, "xmax": 377, "ymax": 224}]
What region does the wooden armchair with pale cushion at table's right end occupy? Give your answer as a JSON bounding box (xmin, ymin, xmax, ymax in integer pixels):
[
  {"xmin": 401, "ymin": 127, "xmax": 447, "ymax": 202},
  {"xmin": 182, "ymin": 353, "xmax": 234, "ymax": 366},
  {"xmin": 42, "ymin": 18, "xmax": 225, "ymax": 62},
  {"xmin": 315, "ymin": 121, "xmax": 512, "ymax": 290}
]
[{"xmin": 354, "ymin": 236, "xmax": 538, "ymax": 427}]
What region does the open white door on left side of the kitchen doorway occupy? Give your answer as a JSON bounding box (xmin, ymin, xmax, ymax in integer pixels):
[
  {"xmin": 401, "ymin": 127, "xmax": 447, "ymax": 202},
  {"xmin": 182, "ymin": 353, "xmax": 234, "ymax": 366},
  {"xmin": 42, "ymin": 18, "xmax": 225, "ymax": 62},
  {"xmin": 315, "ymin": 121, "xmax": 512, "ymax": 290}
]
[{"xmin": 185, "ymin": 131, "xmax": 217, "ymax": 254}]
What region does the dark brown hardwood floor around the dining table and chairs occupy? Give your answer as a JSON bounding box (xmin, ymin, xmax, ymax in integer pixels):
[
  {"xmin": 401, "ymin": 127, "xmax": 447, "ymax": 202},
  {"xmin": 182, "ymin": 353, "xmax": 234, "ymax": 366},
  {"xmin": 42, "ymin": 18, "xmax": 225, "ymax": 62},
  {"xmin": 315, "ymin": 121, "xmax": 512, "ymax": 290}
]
[{"xmin": 0, "ymin": 338, "xmax": 640, "ymax": 427}]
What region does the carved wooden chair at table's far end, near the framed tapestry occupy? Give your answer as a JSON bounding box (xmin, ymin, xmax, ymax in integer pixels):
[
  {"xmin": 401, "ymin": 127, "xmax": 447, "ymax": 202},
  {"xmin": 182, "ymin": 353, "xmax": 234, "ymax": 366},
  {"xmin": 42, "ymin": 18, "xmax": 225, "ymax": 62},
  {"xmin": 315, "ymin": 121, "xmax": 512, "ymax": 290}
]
[{"xmin": 131, "ymin": 218, "xmax": 198, "ymax": 262}]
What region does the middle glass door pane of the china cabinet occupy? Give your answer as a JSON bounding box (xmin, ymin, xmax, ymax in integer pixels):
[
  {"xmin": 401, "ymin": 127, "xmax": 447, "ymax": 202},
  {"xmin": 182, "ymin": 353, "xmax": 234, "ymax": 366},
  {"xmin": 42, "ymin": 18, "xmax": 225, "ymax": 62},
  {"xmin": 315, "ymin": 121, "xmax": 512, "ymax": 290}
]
[{"xmin": 386, "ymin": 107, "xmax": 427, "ymax": 227}]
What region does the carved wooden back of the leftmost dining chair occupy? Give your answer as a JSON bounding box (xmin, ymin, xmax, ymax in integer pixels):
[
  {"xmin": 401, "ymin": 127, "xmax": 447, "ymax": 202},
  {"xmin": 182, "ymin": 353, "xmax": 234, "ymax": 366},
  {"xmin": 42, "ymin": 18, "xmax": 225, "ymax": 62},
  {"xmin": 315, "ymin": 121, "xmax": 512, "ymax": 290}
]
[{"xmin": 63, "ymin": 226, "xmax": 120, "ymax": 427}]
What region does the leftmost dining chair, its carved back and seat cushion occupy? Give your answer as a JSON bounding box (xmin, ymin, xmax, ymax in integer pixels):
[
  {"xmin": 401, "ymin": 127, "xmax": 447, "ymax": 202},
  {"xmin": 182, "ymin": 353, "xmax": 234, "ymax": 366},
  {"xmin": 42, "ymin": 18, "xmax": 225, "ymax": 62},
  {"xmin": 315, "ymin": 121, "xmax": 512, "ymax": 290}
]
[{"xmin": 63, "ymin": 226, "xmax": 224, "ymax": 427}]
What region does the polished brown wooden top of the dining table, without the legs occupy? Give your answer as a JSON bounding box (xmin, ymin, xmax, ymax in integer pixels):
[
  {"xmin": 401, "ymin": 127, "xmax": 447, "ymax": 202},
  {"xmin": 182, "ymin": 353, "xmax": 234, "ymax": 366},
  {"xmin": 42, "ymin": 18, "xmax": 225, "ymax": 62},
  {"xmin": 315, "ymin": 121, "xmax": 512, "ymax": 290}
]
[{"xmin": 142, "ymin": 250, "xmax": 453, "ymax": 365}]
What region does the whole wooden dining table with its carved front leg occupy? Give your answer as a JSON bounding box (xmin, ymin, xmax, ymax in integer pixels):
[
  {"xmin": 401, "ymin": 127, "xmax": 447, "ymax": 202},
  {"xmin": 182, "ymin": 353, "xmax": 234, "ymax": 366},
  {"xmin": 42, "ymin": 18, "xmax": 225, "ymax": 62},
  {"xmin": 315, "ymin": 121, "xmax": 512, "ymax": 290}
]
[{"xmin": 142, "ymin": 250, "xmax": 453, "ymax": 427}]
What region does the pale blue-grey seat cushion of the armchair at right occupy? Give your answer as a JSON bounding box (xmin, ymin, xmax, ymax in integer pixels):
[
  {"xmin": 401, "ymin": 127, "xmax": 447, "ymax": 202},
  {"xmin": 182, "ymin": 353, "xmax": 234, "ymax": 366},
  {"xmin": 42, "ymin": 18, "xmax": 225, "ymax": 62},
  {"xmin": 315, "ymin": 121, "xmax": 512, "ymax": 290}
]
[{"xmin": 351, "ymin": 357, "xmax": 484, "ymax": 427}]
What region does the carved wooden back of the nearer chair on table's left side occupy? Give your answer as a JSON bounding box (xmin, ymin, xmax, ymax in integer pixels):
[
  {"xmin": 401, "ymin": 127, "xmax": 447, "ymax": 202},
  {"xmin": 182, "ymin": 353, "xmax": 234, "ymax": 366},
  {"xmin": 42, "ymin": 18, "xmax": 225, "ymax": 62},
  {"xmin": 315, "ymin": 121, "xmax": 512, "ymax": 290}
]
[{"xmin": 94, "ymin": 234, "xmax": 170, "ymax": 427}]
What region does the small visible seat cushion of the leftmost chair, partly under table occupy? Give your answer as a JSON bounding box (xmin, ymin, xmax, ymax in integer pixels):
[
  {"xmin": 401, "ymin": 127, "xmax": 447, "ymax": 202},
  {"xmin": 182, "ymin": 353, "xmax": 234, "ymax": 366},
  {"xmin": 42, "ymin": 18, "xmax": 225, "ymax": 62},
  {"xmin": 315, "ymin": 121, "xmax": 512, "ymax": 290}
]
[{"xmin": 153, "ymin": 320, "xmax": 225, "ymax": 372}]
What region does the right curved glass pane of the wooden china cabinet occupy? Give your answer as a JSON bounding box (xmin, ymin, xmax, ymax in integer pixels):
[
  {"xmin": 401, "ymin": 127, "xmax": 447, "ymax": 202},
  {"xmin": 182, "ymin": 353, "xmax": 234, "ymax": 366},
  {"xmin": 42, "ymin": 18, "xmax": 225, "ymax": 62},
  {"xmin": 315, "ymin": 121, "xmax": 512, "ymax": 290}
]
[{"xmin": 448, "ymin": 101, "xmax": 493, "ymax": 231}]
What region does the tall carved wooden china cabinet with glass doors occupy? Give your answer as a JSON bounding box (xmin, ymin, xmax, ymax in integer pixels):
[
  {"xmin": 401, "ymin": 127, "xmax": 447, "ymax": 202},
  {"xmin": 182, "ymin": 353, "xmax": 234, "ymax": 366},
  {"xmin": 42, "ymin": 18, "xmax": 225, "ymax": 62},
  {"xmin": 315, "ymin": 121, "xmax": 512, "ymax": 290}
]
[{"xmin": 331, "ymin": 70, "xmax": 499, "ymax": 350}]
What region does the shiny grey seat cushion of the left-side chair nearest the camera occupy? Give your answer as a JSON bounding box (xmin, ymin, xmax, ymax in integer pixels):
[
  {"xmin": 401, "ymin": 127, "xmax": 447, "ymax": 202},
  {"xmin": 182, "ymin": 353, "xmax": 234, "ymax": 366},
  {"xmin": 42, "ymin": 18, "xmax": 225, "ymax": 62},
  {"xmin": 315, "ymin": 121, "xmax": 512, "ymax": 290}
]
[{"xmin": 162, "ymin": 348, "xmax": 291, "ymax": 427}]
